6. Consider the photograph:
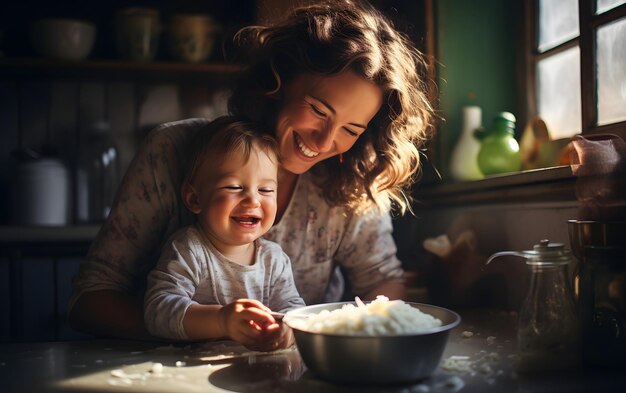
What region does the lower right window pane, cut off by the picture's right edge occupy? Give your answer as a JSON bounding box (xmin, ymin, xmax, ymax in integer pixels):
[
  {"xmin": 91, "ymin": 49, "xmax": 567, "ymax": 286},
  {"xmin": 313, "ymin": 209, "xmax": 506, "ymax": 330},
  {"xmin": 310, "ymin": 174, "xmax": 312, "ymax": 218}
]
[{"xmin": 596, "ymin": 18, "xmax": 626, "ymax": 125}]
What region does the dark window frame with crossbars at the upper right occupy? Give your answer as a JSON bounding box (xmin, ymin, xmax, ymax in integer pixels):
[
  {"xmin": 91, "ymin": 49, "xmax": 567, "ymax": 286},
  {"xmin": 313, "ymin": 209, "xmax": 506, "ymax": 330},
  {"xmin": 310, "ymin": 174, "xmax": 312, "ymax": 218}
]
[{"xmin": 522, "ymin": 0, "xmax": 626, "ymax": 139}]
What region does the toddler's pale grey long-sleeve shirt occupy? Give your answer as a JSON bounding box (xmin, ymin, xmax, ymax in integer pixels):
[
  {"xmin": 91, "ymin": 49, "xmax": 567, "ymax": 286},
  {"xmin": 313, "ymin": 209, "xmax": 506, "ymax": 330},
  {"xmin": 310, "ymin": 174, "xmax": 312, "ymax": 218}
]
[{"xmin": 144, "ymin": 226, "xmax": 304, "ymax": 340}]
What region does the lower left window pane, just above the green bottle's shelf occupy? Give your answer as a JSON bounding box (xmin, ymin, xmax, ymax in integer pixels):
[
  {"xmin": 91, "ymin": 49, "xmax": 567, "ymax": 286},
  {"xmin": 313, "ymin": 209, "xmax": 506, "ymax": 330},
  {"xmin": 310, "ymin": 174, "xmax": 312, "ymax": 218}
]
[{"xmin": 537, "ymin": 47, "xmax": 582, "ymax": 139}]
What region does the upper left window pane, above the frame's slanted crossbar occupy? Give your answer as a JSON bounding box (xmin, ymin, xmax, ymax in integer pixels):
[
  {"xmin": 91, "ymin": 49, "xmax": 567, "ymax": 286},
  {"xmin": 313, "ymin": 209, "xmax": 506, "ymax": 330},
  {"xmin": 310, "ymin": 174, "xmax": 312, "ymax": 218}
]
[{"xmin": 537, "ymin": 0, "xmax": 580, "ymax": 52}]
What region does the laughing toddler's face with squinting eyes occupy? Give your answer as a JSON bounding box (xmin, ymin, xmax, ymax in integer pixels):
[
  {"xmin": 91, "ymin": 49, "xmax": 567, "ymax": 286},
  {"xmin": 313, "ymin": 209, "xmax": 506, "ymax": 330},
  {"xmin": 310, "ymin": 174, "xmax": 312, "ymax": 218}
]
[{"xmin": 192, "ymin": 149, "xmax": 278, "ymax": 248}]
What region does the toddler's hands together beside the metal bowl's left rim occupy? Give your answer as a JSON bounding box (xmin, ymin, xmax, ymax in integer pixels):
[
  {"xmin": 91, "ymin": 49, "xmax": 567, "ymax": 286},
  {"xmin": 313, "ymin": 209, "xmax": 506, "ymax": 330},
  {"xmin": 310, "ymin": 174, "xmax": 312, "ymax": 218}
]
[{"xmin": 219, "ymin": 299, "xmax": 293, "ymax": 352}]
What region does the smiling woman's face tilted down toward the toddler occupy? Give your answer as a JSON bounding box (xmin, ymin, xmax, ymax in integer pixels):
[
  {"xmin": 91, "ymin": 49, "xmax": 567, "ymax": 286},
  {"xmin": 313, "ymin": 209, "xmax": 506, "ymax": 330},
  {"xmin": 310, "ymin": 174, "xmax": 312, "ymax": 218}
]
[{"xmin": 276, "ymin": 71, "xmax": 383, "ymax": 174}]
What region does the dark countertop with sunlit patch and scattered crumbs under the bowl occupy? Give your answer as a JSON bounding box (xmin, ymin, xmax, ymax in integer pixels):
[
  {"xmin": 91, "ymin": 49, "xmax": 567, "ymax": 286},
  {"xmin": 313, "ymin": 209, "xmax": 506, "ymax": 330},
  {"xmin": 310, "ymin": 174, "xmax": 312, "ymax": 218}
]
[{"xmin": 0, "ymin": 310, "xmax": 626, "ymax": 393}]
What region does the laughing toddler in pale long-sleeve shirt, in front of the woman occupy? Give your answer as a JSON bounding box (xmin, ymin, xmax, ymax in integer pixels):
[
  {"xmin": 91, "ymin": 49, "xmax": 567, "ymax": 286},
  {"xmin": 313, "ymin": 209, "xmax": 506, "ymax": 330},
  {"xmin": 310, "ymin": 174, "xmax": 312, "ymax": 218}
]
[{"xmin": 144, "ymin": 116, "xmax": 304, "ymax": 351}]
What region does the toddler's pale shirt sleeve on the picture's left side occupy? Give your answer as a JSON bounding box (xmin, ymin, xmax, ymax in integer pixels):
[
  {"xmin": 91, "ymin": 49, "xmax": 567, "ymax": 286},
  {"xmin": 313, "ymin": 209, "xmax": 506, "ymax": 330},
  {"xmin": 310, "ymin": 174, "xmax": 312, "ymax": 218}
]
[{"xmin": 144, "ymin": 233, "xmax": 206, "ymax": 340}]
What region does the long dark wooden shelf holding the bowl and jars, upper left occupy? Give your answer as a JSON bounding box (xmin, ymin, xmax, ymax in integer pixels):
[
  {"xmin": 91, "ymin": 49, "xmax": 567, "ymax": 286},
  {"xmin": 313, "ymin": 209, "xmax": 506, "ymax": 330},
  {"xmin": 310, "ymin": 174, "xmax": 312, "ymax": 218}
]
[{"xmin": 0, "ymin": 58, "xmax": 245, "ymax": 82}]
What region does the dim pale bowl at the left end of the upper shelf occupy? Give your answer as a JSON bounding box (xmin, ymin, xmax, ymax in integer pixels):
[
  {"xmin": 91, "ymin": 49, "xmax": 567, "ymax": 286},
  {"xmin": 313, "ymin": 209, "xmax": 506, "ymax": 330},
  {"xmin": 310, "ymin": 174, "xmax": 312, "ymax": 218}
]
[{"xmin": 30, "ymin": 18, "xmax": 96, "ymax": 60}]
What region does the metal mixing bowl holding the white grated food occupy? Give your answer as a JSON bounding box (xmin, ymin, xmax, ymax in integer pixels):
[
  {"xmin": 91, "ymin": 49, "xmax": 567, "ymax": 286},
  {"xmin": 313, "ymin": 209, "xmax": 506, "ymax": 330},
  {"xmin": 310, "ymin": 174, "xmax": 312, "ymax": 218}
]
[{"xmin": 284, "ymin": 302, "xmax": 461, "ymax": 384}]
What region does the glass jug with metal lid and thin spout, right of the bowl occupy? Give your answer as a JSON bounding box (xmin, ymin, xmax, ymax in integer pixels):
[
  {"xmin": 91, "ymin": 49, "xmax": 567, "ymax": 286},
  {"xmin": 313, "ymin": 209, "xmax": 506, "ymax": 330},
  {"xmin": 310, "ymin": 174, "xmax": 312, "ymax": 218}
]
[{"xmin": 487, "ymin": 239, "xmax": 580, "ymax": 374}]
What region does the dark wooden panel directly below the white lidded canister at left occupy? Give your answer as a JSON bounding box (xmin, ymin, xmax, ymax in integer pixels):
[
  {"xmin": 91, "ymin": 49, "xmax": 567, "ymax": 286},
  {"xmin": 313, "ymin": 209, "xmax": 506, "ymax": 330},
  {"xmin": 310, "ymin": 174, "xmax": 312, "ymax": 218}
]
[{"xmin": 15, "ymin": 258, "xmax": 57, "ymax": 341}]
